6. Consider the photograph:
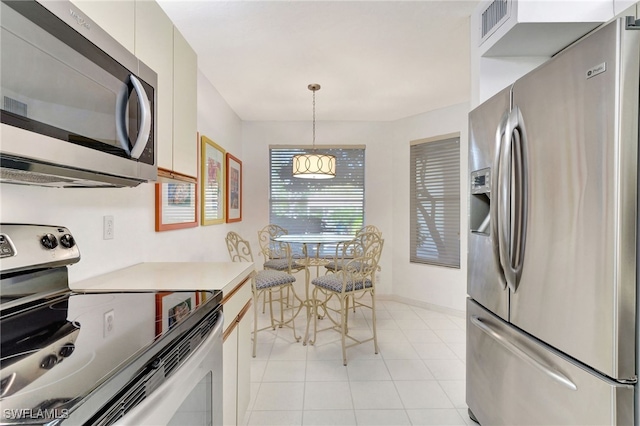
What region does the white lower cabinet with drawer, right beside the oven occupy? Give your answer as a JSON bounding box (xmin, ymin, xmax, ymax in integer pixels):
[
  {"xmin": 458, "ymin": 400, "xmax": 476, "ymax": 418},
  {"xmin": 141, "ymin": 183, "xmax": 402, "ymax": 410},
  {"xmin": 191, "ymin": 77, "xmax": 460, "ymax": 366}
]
[{"xmin": 222, "ymin": 277, "xmax": 253, "ymax": 425}]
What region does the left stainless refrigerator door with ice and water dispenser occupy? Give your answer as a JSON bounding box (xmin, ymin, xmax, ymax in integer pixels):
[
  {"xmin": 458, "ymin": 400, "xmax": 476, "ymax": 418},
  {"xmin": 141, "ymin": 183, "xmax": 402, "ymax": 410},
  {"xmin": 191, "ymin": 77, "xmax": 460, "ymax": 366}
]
[{"xmin": 467, "ymin": 88, "xmax": 511, "ymax": 319}]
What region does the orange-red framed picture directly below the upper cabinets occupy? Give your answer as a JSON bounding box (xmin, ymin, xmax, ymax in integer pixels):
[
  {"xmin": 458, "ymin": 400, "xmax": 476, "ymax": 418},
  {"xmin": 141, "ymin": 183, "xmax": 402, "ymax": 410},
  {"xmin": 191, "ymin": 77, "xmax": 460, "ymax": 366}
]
[{"xmin": 155, "ymin": 169, "xmax": 198, "ymax": 232}]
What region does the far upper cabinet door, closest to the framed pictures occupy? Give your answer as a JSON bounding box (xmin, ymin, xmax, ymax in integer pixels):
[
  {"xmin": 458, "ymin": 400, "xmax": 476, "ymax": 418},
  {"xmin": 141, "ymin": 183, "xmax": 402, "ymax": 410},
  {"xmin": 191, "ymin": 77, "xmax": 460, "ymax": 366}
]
[{"xmin": 173, "ymin": 28, "xmax": 198, "ymax": 177}]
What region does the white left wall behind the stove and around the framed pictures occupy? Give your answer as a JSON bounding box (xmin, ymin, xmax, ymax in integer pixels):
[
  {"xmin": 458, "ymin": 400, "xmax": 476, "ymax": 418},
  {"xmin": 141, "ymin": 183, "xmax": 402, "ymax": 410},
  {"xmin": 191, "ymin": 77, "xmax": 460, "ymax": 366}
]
[{"xmin": 0, "ymin": 70, "xmax": 241, "ymax": 282}]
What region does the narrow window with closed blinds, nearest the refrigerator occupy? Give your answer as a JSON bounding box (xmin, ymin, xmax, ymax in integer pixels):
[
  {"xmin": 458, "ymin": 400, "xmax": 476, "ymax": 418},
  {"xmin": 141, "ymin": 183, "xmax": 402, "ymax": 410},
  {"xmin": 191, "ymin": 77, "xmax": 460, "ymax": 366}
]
[{"xmin": 410, "ymin": 136, "xmax": 460, "ymax": 268}]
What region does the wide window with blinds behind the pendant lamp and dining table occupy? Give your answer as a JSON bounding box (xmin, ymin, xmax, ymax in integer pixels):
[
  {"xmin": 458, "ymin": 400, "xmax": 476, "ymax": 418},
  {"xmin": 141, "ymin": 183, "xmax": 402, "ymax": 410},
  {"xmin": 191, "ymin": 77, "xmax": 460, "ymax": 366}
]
[{"xmin": 269, "ymin": 146, "xmax": 364, "ymax": 254}]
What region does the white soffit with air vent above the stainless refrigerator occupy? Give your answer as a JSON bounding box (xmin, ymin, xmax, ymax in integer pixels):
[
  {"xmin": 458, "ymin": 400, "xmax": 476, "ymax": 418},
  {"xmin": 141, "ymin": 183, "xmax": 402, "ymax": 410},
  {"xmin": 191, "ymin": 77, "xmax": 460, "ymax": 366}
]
[{"xmin": 471, "ymin": 0, "xmax": 638, "ymax": 108}]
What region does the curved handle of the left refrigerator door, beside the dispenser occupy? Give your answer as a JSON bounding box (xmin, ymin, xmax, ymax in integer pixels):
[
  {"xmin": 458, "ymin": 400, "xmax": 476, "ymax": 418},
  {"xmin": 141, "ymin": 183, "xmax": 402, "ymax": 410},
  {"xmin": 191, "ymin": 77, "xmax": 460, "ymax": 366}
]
[{"xmin": 489, "ymin": 111, "xmax": 509, "ymax": 289}]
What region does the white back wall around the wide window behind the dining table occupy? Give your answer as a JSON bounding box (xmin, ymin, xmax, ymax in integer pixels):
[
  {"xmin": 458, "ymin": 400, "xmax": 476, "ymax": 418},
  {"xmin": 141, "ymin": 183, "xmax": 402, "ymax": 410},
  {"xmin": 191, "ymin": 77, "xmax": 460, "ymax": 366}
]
[{"xmin": 242, "ymin": 121, "xmax": 394, "ymax": 294}]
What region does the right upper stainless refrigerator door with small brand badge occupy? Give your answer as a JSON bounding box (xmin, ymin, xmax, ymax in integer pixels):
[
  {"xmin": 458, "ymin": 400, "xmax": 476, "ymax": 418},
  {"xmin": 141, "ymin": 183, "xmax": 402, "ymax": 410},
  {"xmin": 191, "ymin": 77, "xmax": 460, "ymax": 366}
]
[{"xmin": 510, "ymin": 21, "xmax": 640, "ymax": 379}]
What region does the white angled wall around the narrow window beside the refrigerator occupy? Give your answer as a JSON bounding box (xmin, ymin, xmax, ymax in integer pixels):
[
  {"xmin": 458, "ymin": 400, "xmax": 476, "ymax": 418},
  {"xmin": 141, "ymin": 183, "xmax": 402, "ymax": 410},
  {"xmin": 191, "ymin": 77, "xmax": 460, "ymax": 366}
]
[{"xmin": 388, "ymin": 103, "xmax": 469, "ymax": 311}]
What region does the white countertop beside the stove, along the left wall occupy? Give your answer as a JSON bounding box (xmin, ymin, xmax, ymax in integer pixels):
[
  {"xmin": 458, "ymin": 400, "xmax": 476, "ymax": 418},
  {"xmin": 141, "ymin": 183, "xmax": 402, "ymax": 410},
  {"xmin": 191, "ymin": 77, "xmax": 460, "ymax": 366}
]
[{"xmin": 69, "ymin": 262, "xmax": 254, "ymax": 292}]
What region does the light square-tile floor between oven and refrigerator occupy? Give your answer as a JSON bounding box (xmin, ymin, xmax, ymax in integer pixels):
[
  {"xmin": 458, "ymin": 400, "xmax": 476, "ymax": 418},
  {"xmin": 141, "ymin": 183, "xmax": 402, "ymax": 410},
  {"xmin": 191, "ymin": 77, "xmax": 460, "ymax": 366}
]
[{"xmin": 244, "ymin": 300, "xmax": 475, "ymax": 425}]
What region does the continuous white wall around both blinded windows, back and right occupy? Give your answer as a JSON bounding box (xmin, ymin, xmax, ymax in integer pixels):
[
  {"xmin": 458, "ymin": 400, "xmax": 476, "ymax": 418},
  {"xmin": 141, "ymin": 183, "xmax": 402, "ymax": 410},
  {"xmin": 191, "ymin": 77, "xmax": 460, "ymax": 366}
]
[{"xmin": 242, "ymin": 103, "xmax": 469, "ymax": 311}]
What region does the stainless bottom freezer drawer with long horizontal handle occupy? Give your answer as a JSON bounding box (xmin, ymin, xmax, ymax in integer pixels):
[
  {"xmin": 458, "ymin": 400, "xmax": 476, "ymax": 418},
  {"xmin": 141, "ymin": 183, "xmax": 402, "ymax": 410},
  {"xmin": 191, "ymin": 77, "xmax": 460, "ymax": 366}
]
[{"xmin": 467, "ymin": 299, "xmax": 634, "ymax": 426}]
